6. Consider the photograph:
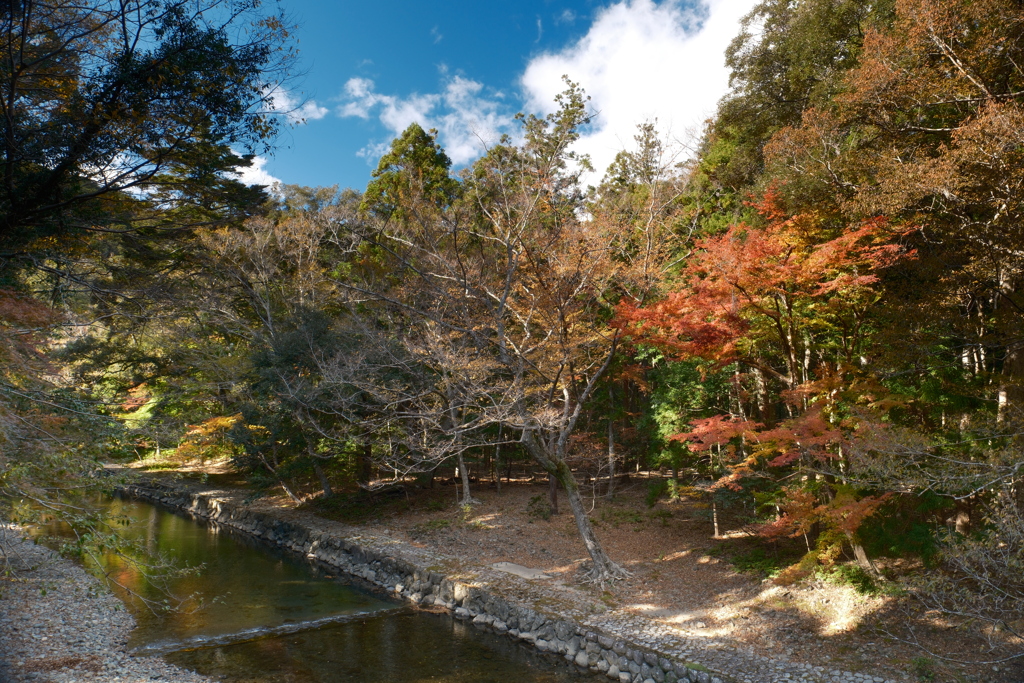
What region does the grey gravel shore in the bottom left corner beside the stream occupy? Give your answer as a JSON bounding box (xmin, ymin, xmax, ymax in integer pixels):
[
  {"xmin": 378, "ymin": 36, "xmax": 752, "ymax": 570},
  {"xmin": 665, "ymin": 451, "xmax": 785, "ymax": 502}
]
[{"xmin": 0, "ymin": 524, "xmax": 212, "ymax": 683}]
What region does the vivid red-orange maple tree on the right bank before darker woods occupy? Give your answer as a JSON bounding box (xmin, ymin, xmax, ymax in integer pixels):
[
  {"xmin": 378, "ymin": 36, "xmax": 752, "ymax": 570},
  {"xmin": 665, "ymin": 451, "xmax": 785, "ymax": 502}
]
[{"xmin": 617, "ymin": 190, "xmax": 912, "ymax": 566}]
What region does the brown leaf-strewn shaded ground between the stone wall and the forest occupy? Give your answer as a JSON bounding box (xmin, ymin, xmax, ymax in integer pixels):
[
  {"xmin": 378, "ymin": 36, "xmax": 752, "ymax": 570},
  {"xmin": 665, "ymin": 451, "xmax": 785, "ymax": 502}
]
[{"xmin": 132, "ymin": 468, "xmax": 1024, "ymax": 683}]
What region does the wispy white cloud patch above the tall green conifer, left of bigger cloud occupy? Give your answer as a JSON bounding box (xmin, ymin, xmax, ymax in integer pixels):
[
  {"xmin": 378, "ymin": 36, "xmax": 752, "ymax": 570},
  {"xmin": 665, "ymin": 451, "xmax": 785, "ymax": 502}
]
[{"xmin": 337, "ymin": 76, "xmax": 513, "ymax": 165}]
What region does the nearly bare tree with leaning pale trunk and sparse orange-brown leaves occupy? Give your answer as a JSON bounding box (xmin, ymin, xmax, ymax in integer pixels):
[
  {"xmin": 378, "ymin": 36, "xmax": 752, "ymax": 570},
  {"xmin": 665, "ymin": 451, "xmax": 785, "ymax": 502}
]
[{"xmin": 349, "ymin": 85, "xmax": 623, "ymax": 582}]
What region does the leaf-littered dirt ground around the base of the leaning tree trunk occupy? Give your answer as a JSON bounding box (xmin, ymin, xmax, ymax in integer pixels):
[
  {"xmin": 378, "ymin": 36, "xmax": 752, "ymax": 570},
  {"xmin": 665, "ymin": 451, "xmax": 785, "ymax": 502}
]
[{"xmin": 339, "ymin": 485, "xmax": 1011, "ymax": 683}]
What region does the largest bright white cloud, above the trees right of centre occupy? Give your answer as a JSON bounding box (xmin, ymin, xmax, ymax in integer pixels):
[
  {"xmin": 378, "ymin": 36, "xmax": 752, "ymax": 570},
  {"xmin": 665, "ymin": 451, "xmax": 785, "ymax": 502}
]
[{"xmin": 521, "ymin": 0, "xmax": 756, "ymax": 179}]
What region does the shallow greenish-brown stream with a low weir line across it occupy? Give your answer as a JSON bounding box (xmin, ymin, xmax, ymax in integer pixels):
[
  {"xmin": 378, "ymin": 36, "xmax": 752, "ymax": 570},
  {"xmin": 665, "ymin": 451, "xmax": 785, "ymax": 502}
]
[{"xmin": 41, "ymin": 499, "xmax": 580, "ymax": 683}]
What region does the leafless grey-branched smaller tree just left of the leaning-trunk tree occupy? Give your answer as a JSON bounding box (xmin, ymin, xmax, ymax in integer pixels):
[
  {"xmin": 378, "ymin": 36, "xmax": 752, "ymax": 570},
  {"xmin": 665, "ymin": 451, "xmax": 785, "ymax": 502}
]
[{"xmin": 307, "ymin": 310, "xmax": 507, "ymax": 505}]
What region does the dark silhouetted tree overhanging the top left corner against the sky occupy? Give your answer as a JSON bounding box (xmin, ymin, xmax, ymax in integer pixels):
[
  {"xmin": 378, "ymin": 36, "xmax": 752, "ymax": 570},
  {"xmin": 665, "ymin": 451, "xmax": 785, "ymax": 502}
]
[{"xmin": 0, "ymin": 0, "xmax": 289, "ymax": 250}]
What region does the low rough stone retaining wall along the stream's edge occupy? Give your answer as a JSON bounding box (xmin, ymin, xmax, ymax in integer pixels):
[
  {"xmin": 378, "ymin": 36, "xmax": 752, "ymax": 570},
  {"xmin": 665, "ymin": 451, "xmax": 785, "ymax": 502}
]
[{"xmin": 121, "ymin": 482, "xmax": 728, "ymax": 683}]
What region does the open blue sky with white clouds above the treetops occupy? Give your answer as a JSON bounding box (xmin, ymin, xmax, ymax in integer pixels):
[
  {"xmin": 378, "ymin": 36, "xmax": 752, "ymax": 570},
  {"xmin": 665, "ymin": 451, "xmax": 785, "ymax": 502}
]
[{"xmin": 245, "ymin": 0, "xmax": 754, "ymax": 192}]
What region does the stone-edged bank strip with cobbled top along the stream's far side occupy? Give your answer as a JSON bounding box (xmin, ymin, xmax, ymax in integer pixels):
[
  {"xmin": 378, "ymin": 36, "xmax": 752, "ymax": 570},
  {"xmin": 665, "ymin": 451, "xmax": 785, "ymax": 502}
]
[{"xmin": 116, "ymin": 478, "xmax": 909, "ymax": 683}]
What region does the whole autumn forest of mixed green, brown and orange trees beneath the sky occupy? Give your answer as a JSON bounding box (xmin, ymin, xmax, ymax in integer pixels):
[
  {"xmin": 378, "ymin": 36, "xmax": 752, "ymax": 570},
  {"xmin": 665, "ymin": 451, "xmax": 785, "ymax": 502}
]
[{"xmin": 0, "ymin": 0, "xmax": 1024, "ymax": 663}]
